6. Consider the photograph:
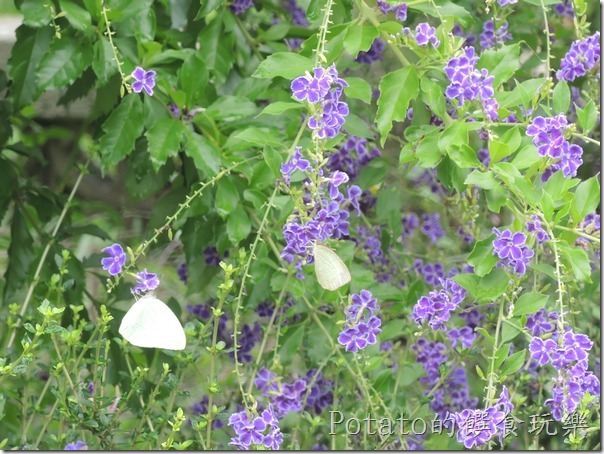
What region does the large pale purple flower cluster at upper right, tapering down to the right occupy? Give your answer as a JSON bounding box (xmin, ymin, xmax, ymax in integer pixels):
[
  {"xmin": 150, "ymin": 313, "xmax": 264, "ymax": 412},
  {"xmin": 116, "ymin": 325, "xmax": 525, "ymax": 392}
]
[{"xmin": 445, "ymin": 47, "xmax": 499, "ymax": 121}]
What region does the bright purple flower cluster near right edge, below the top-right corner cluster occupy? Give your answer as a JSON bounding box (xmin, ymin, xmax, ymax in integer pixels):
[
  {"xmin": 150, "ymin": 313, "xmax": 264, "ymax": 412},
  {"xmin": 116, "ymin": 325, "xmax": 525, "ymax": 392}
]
[{"xmin": 526, "ymin": 114, "xmax": 583, "ymax": 181}]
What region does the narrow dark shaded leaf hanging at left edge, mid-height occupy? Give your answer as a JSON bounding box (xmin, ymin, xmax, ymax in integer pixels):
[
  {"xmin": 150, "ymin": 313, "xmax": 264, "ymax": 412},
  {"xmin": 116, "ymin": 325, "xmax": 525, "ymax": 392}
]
[{"xmin": 4, "ymin": 208, "xmax": 35, "ymax": 302}]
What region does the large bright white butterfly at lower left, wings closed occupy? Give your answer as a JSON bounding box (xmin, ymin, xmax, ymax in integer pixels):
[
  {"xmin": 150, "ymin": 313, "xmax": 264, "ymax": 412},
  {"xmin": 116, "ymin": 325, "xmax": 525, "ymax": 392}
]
[{"xmin": 119, "ymin": 295, "xmax": 187, "ymax": 350}]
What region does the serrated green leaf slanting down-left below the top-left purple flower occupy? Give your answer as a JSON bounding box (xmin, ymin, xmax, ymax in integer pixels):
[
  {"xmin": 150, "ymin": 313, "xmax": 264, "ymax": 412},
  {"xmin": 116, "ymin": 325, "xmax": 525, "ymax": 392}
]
[{"xmin": 99, "ymin": 93, "xmax": 144, "ymax": 168}]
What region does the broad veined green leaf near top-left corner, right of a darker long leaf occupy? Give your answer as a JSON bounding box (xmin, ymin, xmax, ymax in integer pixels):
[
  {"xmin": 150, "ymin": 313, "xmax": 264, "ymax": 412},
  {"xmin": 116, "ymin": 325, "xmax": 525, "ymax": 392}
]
[{"xmin": 37, "ymin": 36, "xmax": 93, "ymax": 93}]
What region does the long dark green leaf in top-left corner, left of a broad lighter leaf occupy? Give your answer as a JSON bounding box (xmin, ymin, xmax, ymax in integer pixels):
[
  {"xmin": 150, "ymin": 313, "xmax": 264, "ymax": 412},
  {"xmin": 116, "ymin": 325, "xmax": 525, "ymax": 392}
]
[{"xmin": 8, "ymin": 25, "xmax": 52, "ymax": 111}]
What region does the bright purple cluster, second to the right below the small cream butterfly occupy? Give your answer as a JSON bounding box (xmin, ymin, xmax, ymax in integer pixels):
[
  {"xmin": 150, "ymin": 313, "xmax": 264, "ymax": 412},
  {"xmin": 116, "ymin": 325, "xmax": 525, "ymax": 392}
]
[{"xmin": 411, "ymin": 279, "xmax": 468, "ymax": 331}]
